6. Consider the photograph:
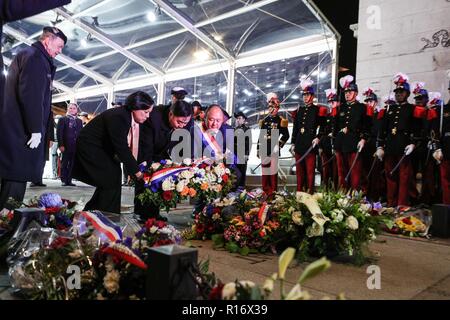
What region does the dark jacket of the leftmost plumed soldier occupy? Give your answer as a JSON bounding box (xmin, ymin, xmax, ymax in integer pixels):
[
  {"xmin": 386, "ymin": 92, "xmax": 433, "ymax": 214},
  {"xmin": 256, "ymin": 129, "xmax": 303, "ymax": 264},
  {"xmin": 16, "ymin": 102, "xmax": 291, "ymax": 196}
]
[{"xmin": 258, "ymin": 115, "xmax": 290, "ymax": 154}]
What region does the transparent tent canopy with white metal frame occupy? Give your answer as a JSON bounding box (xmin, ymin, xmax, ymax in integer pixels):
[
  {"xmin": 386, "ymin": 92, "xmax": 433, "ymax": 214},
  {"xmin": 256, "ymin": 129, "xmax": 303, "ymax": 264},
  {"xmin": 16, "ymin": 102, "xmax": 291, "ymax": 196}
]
[{"xmin": 2, "ymin": 0, "xmax": 340, "ymax": 122}]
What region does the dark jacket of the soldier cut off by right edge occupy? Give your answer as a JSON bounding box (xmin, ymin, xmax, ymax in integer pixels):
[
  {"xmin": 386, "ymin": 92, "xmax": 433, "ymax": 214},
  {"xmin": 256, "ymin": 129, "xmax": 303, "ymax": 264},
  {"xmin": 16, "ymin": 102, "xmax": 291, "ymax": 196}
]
[{"xmin": 431, "ymin": 103, "xmax": 450, "ymax": 160}]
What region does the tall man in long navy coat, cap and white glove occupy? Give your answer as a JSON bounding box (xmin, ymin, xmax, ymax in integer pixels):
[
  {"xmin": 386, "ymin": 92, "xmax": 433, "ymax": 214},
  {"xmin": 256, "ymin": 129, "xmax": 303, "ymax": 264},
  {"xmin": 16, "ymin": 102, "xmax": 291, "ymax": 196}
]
[{"xmin": 0, "ymin": 27, "xmax": 67, "ymax": 208}]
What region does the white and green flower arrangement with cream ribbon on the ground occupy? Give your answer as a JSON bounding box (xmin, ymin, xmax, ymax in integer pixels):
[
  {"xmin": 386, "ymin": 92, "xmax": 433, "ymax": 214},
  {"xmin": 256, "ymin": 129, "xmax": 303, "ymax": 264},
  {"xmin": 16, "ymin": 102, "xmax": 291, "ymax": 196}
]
[{"xmin": 275, "ymin": 192, "xmax": 380, "ymax": 264}]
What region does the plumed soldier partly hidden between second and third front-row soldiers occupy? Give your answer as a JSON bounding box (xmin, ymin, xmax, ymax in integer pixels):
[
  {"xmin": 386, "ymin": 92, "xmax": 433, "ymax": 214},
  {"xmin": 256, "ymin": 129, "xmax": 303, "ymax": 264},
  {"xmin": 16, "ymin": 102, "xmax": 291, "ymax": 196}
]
[{"xmin": 319, "ymin": 89, "xmax": 340, "ymax": 189}]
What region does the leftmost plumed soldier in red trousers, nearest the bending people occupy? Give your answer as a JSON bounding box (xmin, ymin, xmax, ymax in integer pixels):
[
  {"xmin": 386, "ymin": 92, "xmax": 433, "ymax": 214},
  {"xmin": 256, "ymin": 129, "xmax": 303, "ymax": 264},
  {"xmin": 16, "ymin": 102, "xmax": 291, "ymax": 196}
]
[{"xmin": 258, "ymin": 93, "xmax": 289, "ymax": 195}]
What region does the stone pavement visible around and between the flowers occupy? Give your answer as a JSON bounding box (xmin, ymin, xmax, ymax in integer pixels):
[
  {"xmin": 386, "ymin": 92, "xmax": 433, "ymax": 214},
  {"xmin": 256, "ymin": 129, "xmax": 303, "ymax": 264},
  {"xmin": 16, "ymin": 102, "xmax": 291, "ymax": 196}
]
[{"xmin": 0, "ymin": 180, "xmax": 450, "ymax": 300}]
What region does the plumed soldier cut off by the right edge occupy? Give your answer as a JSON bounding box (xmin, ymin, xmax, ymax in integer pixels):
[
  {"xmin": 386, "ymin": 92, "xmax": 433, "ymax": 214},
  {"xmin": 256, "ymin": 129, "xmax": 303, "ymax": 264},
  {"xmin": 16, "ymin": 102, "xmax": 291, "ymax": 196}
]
[{"xmin": 429, "ymin": 91, "xmax": 450, "ymax": 205}]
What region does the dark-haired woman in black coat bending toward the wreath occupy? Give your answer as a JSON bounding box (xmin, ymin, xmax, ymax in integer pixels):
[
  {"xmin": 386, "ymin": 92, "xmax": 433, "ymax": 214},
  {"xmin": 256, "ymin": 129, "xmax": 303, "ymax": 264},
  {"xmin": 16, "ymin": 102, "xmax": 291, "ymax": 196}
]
[{"xmin": 73, "ymin": 91, "xmax": 154, "ymax": 213}]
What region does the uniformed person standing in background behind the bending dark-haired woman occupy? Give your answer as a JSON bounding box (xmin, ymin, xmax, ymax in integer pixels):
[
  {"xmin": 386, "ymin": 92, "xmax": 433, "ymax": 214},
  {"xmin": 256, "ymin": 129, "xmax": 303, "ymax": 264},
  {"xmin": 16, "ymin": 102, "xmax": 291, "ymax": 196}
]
[{"xmin": 56, "ymin": 103, "xmax": 83, "ymax": 186}]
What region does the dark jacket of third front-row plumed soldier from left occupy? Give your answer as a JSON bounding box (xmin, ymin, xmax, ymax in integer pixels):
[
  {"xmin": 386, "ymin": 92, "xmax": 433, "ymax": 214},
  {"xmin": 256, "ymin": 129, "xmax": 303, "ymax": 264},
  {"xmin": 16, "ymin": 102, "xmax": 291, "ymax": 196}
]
[{"xmin": 333, "ymin": 102, "xmax": 371, "ymax": 153}]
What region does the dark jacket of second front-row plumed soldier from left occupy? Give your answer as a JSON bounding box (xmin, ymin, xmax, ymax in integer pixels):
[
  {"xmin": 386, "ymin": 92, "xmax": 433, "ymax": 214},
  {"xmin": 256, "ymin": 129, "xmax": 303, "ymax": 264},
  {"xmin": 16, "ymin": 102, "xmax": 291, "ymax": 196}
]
[{"xmin": 291, "ymin": 104, "xmax": 328, "ymax": 154}]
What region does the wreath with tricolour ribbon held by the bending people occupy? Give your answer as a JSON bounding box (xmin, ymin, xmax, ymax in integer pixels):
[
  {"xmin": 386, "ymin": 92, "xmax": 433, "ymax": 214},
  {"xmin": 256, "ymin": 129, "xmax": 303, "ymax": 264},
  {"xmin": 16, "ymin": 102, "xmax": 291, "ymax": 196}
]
[{"xmin": 139, "ymin": 159, "xmax": 232, "ymax": 212}]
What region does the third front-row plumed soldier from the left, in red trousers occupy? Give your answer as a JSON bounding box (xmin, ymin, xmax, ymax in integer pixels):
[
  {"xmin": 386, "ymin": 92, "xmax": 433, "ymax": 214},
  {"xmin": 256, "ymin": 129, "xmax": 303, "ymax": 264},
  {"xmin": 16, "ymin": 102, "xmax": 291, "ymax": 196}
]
[{"xmin": 333, "ymin": 76, "xmax": 370, "ymax": 190}]
